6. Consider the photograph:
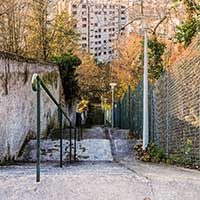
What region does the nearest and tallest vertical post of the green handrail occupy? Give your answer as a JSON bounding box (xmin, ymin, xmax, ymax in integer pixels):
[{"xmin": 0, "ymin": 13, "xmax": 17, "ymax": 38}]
[{"xmin": 36, "ymin": 79, "xmax": 40, "ymax": 182}]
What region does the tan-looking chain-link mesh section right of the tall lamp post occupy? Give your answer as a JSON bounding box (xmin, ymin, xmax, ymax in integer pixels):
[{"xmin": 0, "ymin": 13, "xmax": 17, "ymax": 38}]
[{"xmin": 153, "ymin": 37, "xmax": 200, "ymax": 162}]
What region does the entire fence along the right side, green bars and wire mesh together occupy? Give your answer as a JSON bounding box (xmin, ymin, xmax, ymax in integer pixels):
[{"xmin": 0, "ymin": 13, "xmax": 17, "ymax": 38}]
[{"xmin": 112, "ymin": 38, "xmax": 200, "ymax": 163}]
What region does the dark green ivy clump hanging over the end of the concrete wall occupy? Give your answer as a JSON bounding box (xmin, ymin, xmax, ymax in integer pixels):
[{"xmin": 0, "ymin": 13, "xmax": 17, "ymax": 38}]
[{"xmin": 53, "ymin": 52, "xmax": 81, "ymax": 101}]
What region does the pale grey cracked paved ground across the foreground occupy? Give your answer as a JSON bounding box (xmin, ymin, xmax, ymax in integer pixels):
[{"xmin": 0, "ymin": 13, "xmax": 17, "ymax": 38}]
[{"xmin": 0, "ymin": 127, "xmax": 200, "ymax": 200}]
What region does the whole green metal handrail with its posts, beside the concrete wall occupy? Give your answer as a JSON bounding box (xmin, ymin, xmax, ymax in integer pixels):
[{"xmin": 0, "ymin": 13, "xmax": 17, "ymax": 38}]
[{"xmin": 32, "ymin": 74, "xmax": 79, "ymax": 182}]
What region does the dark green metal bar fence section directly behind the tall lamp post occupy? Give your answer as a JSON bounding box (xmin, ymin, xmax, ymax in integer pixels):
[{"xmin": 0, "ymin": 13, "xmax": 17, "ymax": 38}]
[{"xmin": 114, "ymin": 81, "xmax": 154, "ymax": 139}]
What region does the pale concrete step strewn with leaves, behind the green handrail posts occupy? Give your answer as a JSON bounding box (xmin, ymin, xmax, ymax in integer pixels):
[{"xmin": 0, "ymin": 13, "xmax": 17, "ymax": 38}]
[{"xmin": 18, "ymin": 139, "xmax": 113, "ymax": 162}]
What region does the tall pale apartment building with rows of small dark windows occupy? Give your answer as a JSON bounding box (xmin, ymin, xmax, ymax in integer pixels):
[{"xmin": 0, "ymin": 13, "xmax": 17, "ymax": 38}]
[{"xmin": 69, "ymin": 0, "xmax": 128, "ymax": 62}]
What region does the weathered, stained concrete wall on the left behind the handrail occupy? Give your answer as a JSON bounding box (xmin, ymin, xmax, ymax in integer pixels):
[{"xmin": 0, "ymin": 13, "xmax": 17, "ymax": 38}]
[{"xmin": 0, "ymin": 52, "xmax": 73, "ymax": 161}]
